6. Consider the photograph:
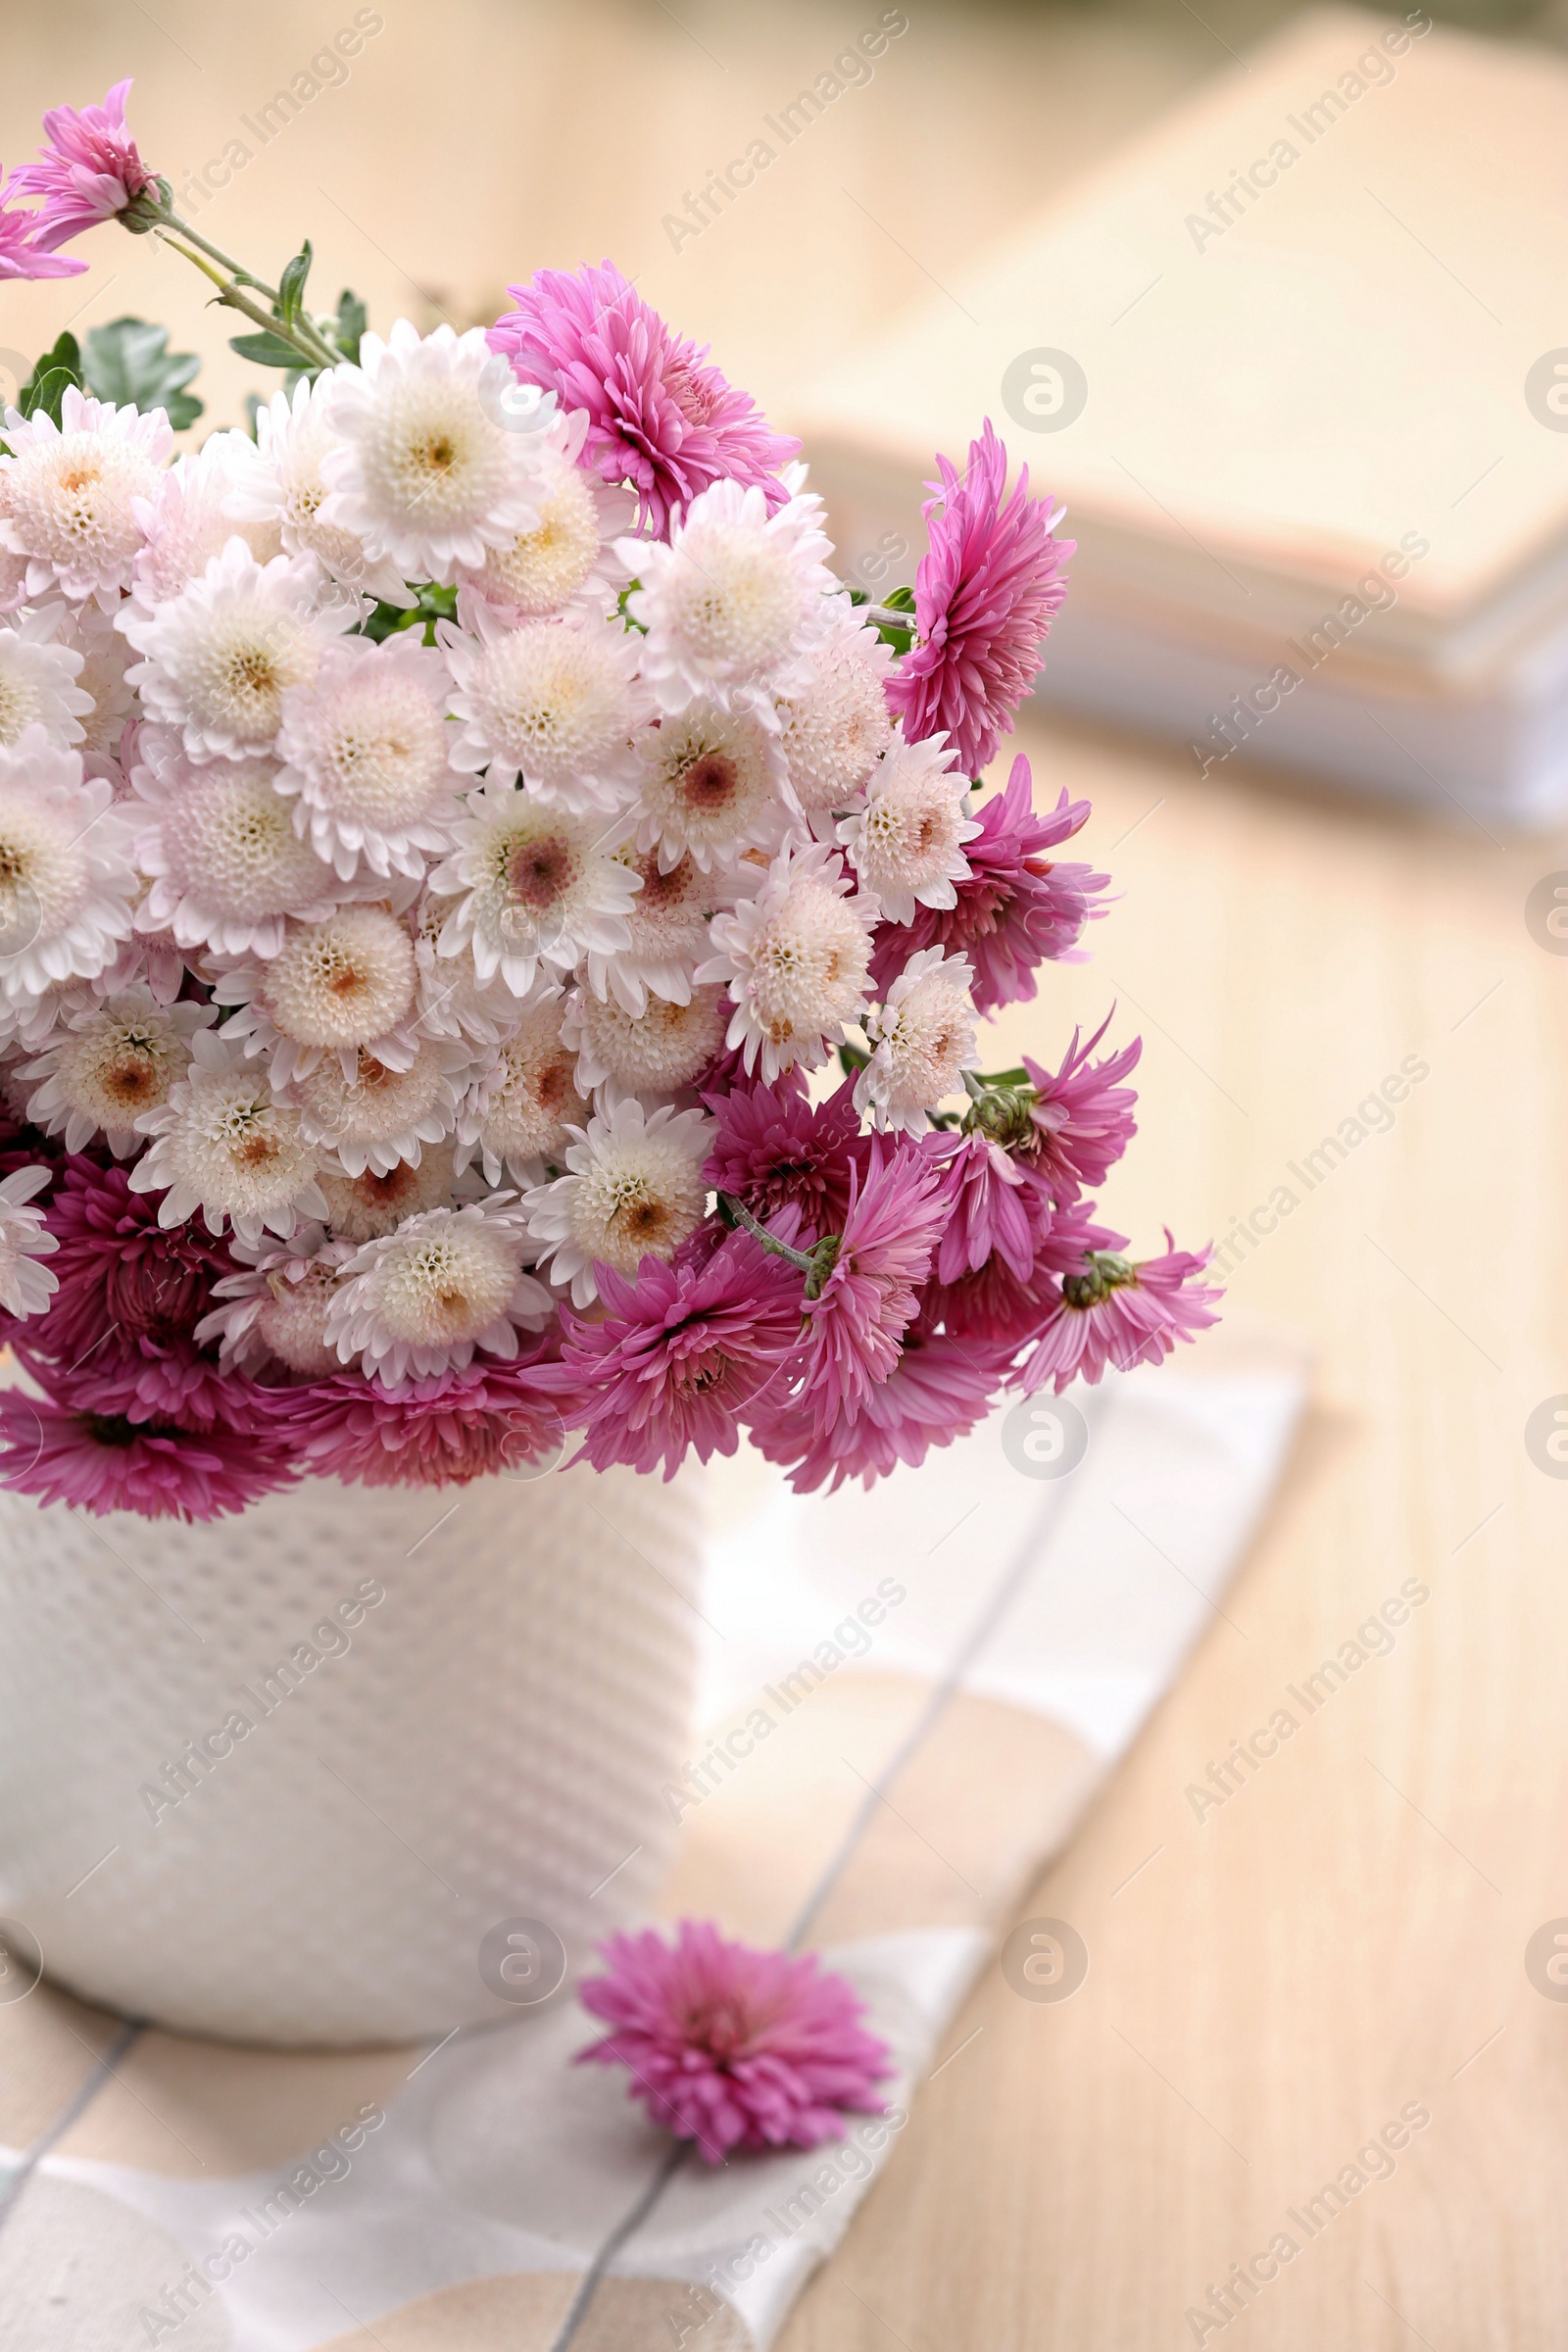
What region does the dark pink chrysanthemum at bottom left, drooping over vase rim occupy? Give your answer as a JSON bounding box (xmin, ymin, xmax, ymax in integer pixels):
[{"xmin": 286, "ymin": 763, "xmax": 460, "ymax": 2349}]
[{"xmin": 0, "ymin": 1388, "xmax": 294, "ymax": 1519}]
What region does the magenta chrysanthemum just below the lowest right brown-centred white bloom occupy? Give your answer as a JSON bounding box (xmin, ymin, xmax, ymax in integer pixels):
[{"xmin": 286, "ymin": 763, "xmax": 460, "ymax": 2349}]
[{"xmin": 564, "ymin": 1233, "xmax": 802, "ymax": 1480}]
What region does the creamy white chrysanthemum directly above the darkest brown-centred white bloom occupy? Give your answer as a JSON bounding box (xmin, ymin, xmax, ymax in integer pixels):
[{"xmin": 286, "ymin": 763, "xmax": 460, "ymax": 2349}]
[{"xmin": 440, "ymin": 598, "xmax": 651, "ymax": 816}]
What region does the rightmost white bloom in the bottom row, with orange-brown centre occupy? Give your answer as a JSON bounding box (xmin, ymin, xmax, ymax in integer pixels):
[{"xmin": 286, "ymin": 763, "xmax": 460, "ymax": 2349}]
[{"xmin": 522, "ymin": 1099, "xmax": 717, "ymax": 1307}]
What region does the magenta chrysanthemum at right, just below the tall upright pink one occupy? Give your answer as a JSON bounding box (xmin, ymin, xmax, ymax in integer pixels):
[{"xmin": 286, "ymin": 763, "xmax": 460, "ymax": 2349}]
[{"xmin": 872, "ymin": 753, "xmax": 1109, "ymax": 1011}]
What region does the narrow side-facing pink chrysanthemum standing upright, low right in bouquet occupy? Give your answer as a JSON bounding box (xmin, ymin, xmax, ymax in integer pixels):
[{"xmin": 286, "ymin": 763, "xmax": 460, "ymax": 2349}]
[{"xmin": 800, "ymin": 1141, "xmax": 948, "ymax": 1428}]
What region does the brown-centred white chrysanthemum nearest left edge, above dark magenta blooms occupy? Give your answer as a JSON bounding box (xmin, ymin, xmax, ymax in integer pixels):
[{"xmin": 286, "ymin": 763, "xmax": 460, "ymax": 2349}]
[{"xmin": 22, "ymin": 988, "xmax": 217, "ymax": 1159}]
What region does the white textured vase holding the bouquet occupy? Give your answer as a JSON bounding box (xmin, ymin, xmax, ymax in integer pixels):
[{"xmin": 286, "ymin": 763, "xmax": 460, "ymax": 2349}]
[{"xmin": 0, "ymin": 1465, "xmax": 701, "ymax": 2044}]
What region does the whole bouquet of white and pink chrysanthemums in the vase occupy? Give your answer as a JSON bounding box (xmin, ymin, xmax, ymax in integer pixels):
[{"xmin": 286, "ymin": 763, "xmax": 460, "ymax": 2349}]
[{"xmin": 0, "ymin": 84, "xmax": 1213, "ymax": 1517}]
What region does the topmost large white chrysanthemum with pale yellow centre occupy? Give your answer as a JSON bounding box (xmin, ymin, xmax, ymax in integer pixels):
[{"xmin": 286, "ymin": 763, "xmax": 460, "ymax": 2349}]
[{"xmin": 322, "ymin": 318, "xmax": 555, "ymax": 583}]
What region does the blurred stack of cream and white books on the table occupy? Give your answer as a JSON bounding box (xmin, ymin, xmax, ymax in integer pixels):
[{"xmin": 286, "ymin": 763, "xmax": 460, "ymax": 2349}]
[{"xmin": 792, "ymin": 10, "xmax": 1568, "ymax": 830}]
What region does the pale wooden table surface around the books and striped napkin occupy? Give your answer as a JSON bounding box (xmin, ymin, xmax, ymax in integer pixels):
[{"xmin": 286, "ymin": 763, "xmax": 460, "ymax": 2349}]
[{"xmin": 0, "ymin": 0, "xmax": 1568, "ymax": 2352}]
